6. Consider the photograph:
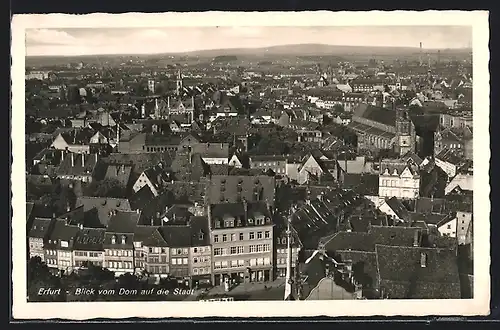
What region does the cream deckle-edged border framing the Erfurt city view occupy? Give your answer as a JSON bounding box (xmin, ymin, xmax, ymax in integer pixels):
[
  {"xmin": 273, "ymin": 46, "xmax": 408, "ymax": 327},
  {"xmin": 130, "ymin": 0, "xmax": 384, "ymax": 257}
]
[{"xmin": 11, "ymin": 11, "xmax": 490, "ymax": 320}]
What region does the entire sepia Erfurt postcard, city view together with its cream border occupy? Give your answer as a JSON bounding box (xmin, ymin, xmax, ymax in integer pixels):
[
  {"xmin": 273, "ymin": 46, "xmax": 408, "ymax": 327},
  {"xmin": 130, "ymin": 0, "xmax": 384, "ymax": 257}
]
[{"xmin": 12, "ymin": 12, "xmax": 490, "ymax": 318}]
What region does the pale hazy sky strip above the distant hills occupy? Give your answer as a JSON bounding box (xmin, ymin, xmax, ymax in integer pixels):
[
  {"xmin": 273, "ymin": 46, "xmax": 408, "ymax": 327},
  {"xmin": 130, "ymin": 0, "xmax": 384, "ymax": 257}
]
[{"xmin": 26, "ymin": 26, "xmax": 472, "ymax": 56}]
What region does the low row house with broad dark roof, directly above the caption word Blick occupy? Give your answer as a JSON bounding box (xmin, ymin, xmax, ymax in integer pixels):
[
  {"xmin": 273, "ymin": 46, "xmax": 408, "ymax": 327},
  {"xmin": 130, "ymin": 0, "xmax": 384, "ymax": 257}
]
[{"xmin": 73, "ymin": 227, "xmax": 106, "ymax": 269}]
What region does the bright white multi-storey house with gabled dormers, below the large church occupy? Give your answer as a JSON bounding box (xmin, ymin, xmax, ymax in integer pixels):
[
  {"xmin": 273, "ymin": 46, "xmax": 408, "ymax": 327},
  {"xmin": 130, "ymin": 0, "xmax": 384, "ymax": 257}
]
[{"xmin": 379, "ymin": 159, "xmax": 420, "ymax": 199}]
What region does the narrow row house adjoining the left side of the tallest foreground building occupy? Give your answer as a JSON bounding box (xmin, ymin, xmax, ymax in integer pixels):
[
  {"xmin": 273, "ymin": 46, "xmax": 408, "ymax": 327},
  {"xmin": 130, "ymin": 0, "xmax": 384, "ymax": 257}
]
[{"xmin": 189, "ymin": 216, "xmax": 212, "ymax": 286}]
